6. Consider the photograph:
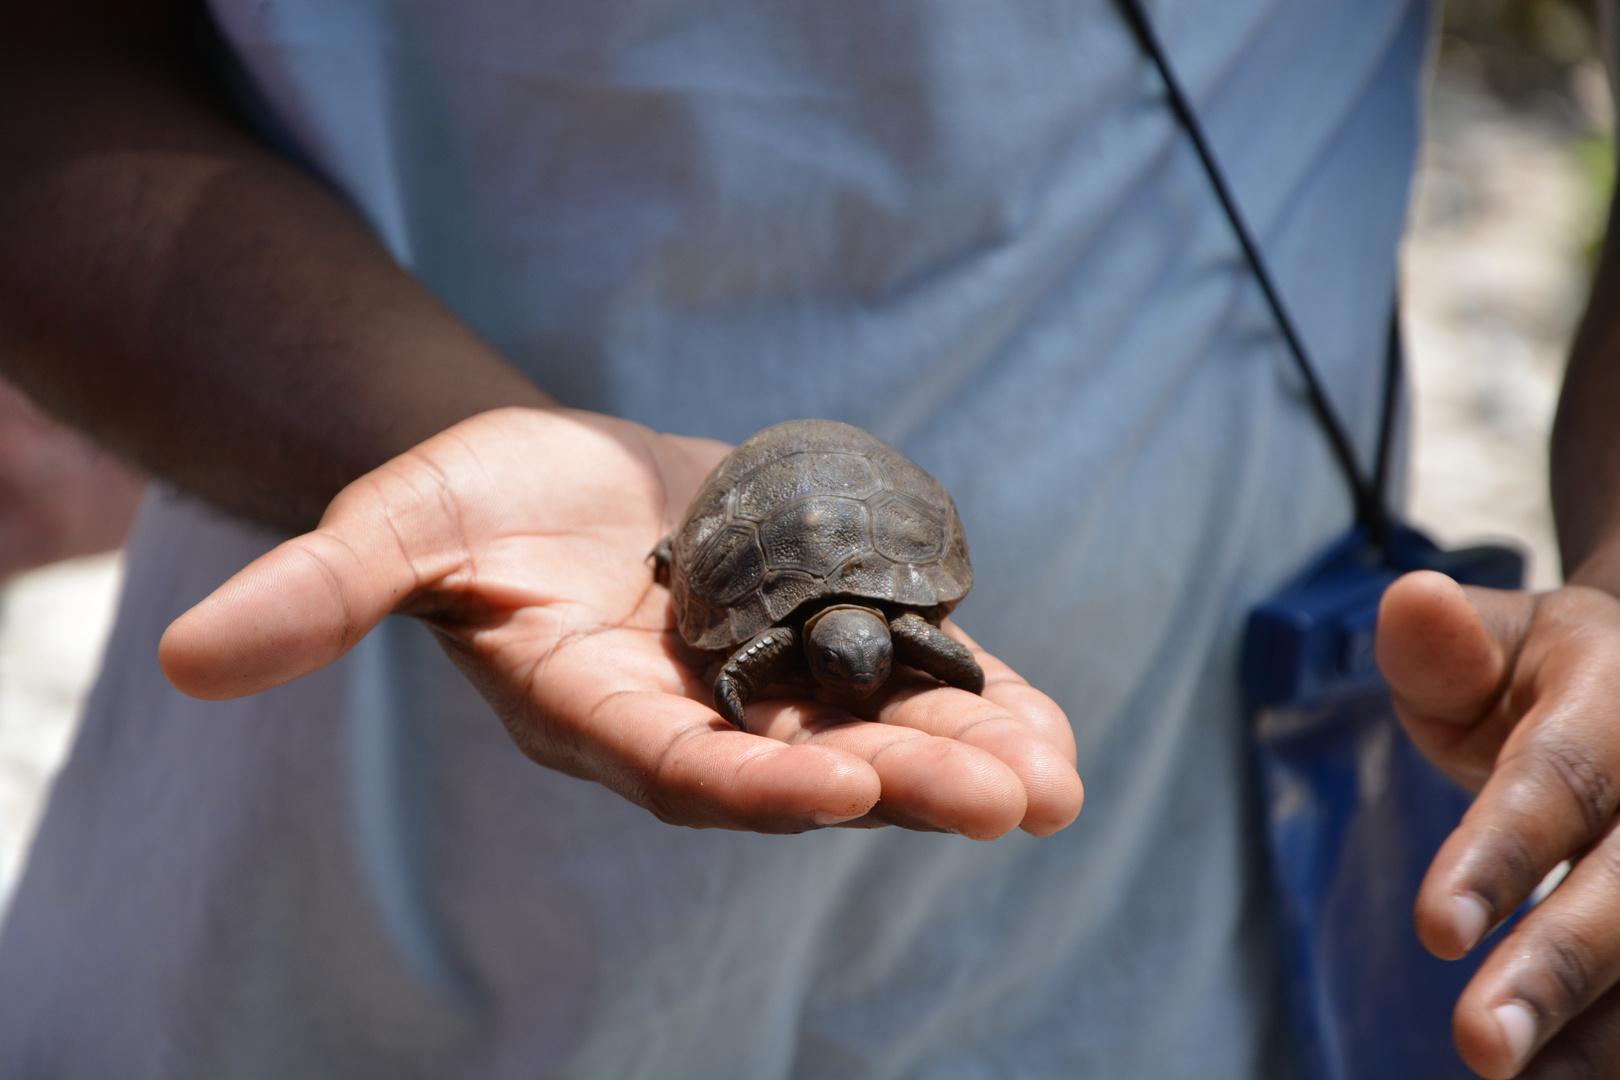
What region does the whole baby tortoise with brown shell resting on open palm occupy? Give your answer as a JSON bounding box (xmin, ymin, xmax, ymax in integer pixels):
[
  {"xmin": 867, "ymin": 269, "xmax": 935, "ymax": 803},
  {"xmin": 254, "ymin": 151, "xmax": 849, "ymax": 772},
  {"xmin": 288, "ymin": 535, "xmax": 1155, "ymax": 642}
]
[{"xmin": 653, "ymin": 419, "xmax": 985, "ymax": 730}]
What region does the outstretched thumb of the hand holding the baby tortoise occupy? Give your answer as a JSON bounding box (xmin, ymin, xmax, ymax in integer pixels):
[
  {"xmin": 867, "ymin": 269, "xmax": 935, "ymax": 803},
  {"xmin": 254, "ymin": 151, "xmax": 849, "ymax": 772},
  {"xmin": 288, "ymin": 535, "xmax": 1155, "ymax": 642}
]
[{"xmin": 157, "ymin": 487, "xmax": 442, "ymax": 699}]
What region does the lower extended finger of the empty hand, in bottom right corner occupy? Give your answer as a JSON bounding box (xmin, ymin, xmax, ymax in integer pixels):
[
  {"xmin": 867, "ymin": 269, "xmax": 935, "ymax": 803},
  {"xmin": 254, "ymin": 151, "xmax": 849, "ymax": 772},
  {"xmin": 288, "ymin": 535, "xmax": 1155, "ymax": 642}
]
[{"xmin": 1453, "ymin": 824, "xmax": 1620, "ymax": 1077}]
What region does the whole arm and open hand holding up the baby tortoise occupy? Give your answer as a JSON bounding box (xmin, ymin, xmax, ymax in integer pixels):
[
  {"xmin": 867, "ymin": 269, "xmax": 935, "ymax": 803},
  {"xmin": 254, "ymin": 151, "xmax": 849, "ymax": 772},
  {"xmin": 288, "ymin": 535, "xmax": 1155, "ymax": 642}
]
[{"xmin": 0, "ymin": 0, "xmax": 1082, "ymax": 839}]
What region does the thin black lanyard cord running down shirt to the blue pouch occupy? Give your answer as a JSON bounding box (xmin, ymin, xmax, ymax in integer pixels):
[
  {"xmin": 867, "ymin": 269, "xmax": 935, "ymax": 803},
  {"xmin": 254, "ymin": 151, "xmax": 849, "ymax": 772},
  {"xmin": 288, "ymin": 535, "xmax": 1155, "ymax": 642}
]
[{"xmin": 1119, "ymin": 0, "xmax": 1400, "ymax": 542}]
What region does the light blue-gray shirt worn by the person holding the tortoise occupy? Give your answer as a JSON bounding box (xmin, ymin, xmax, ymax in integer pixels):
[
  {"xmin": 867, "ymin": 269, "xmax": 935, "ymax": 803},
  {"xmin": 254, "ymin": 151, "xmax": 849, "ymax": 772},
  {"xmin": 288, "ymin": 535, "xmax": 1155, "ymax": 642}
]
[{"xmin": 0, "ymin": 0, "xmax": 1430, "ymax": 1080}]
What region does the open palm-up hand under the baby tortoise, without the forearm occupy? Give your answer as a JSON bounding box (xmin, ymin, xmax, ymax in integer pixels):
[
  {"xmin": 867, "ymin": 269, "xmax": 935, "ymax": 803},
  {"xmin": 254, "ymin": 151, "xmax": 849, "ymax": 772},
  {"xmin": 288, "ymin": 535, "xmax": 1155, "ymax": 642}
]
[{"xmin": 160, "ymin": 408, "xmax": 1082, "ymax": 839}]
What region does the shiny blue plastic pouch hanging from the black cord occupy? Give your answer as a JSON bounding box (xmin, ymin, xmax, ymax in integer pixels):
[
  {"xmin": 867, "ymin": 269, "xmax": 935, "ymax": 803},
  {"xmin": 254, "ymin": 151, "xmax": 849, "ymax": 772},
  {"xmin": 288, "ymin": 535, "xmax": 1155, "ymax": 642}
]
[{"xmin": 1243, "ymin": 525, "xmax": 1524, "ymax": 1080}]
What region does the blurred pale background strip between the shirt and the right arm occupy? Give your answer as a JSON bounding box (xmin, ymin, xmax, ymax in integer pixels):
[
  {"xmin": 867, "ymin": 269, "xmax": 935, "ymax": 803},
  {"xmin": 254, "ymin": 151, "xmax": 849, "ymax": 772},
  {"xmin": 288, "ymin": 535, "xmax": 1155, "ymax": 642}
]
[{"xmin": 1405, "ymin": 0, "xmax": 1615, "ymax": 588}]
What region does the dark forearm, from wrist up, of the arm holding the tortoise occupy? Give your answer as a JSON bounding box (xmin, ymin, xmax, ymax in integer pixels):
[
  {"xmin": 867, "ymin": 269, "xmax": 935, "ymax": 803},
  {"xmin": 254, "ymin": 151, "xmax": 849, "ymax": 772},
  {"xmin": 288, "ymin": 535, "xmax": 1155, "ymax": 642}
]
[{"xmin": 0, "ymin": 5, "xmax": 548, "ymax": 528}]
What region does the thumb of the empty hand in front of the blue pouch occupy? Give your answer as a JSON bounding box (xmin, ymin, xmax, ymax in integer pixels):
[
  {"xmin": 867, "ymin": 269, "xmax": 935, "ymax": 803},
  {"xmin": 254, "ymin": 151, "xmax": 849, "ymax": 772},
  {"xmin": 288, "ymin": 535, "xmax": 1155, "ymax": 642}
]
[{"xmin": 1377, "ymin": 570, "xmax": 1531, "ymax": 725}]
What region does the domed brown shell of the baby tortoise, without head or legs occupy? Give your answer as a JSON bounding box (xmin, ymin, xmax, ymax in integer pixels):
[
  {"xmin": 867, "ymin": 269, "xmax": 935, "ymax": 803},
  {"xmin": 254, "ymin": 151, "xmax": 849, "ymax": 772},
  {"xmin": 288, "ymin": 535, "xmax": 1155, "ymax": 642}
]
[{"xmin": 669, "ymin": 419, "xmax": 974, "ymax": 653}]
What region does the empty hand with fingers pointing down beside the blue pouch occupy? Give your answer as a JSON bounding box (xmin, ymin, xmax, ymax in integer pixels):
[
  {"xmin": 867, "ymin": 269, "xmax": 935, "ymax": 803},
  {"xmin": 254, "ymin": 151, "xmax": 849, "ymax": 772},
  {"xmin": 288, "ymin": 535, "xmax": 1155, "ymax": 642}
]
[{"xmin": 1377, "ymin": 572, "xmax": 1620, "ymax": 1078}]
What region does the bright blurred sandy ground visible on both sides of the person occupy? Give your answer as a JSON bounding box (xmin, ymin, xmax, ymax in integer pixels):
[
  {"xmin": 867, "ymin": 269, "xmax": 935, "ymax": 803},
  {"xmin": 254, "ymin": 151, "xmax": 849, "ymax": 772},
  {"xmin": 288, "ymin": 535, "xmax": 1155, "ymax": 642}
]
[{"xmin": 0, "ymin": 69, "xmax": 1594, "ymax": 908}]
